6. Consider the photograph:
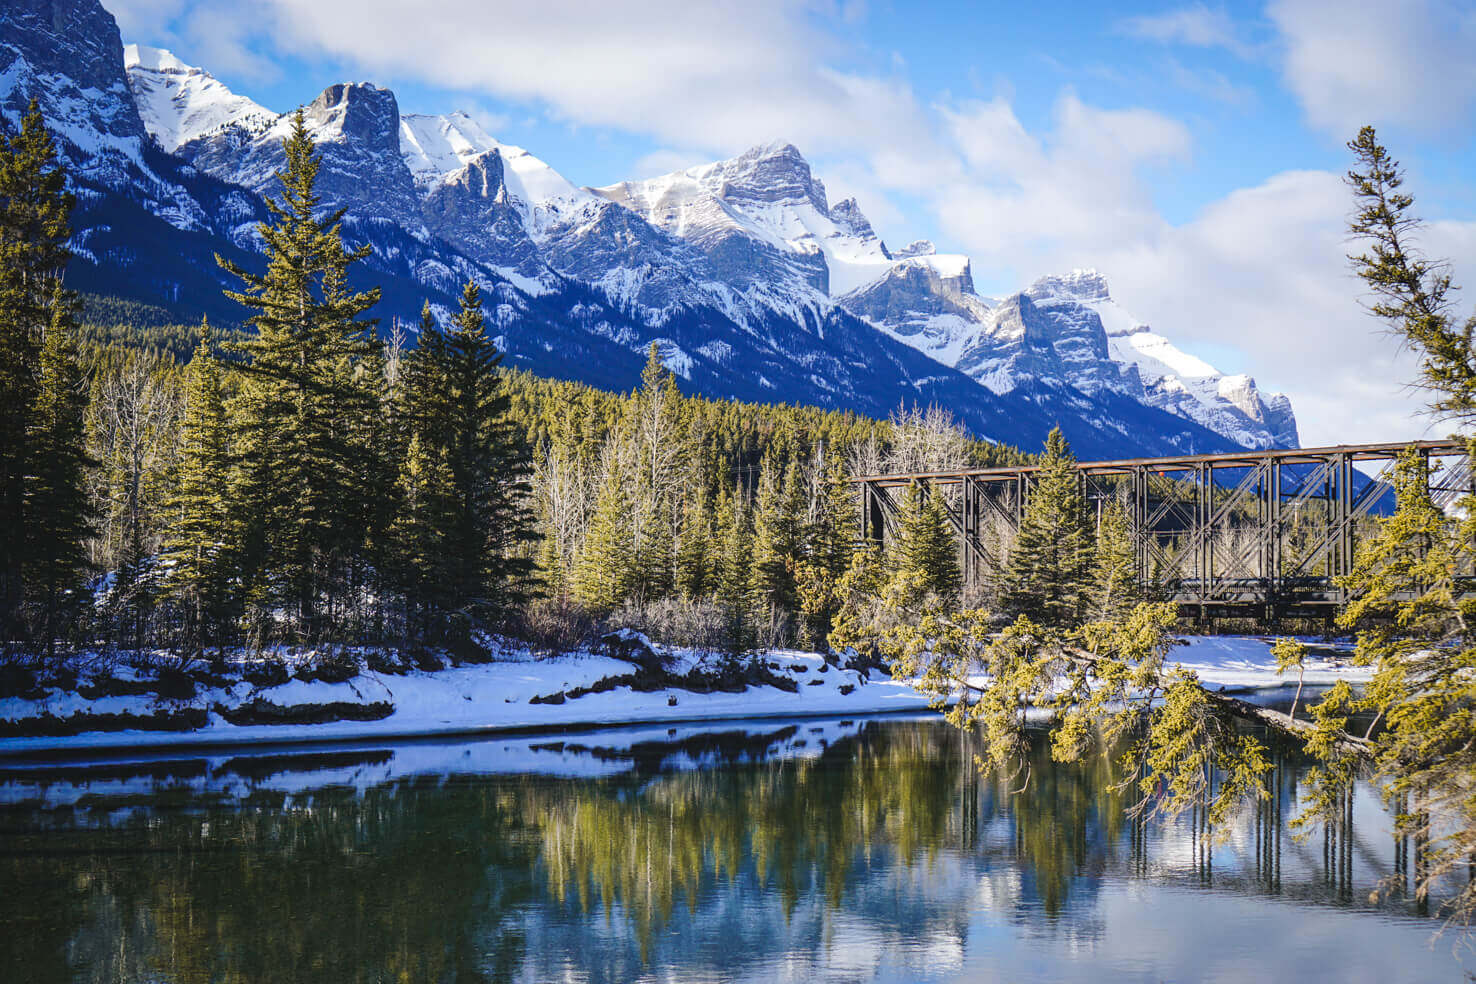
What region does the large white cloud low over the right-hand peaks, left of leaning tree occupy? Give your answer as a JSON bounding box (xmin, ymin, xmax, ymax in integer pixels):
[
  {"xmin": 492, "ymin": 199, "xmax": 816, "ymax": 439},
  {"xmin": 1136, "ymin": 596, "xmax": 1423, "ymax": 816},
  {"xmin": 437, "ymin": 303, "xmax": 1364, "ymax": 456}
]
[{"xmin": 1100, "ymin": 171, "xmax": 1424, "ymax": 444}]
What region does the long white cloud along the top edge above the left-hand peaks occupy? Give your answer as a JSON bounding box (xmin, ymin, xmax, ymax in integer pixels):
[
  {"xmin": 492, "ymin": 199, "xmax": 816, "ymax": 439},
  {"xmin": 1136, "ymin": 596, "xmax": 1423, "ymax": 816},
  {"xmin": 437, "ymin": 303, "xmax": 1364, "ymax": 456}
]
[{"xmin": 242, "ymin": 0, "xmax": 925, "ymax": 163}]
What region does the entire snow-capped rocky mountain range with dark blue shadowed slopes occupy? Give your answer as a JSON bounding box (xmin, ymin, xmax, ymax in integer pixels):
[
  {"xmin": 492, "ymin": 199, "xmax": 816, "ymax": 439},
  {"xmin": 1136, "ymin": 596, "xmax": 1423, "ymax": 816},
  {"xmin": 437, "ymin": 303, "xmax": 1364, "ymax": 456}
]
[{"xmin": 0, "ymin": 0, "xmax": 1294, "ymax": 456}]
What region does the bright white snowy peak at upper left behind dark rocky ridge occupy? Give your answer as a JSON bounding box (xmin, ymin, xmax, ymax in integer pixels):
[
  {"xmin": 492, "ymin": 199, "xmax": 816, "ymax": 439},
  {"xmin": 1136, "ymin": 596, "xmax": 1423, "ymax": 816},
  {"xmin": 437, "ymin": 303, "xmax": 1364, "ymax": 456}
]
[{"xmin": 123, "ymin": 44, "xmax": 279, "ymax": 153}]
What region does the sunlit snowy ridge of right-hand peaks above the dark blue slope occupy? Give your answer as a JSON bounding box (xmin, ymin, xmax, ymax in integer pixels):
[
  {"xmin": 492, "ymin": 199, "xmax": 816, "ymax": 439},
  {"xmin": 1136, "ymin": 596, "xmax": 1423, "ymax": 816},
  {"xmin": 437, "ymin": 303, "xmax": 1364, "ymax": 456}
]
[{"xmin": 584, "ymin": 143, "xmax": 1296, "ymax": 447}]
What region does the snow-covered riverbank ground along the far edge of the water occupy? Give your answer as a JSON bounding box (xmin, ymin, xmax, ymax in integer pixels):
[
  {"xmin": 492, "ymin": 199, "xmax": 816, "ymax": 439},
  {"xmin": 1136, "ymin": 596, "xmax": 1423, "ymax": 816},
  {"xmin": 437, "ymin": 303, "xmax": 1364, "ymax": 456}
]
[{"xmin": 0, "ymin": 636, "xmax": 1368, "ymax": 755}]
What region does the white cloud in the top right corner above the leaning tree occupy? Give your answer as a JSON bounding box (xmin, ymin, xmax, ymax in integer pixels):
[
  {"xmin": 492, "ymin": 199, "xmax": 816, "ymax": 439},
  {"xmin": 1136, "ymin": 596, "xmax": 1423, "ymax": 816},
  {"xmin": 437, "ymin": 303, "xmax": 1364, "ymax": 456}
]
[{"xmin": 1266, "ymin": 0, "xmax": 1476, "ymax": 139}]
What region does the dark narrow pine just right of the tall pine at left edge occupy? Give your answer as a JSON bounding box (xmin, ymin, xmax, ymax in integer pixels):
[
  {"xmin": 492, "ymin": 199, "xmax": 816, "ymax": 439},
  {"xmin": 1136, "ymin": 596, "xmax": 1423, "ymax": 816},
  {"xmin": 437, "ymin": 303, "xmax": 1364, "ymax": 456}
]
[{"xmin": 25, "ymin": 285, "xmax": 93, "ymax": 655}]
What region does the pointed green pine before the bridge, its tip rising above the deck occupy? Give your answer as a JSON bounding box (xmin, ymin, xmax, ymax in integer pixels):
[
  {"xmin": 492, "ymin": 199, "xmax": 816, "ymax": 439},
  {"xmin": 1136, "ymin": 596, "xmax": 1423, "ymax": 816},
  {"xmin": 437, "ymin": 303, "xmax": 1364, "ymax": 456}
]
[{"xmin": 1001, "ymin": 428, "xmax": 1092, "ymax": 628}]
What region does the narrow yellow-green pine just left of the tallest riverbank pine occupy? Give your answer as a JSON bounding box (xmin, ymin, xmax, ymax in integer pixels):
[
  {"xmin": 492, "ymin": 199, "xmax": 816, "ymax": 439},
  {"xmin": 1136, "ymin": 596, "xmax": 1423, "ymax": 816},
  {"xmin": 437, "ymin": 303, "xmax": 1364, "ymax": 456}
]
[{"xmin": 164, "ymin": 325, "xmax": 239, "ymax": 648}]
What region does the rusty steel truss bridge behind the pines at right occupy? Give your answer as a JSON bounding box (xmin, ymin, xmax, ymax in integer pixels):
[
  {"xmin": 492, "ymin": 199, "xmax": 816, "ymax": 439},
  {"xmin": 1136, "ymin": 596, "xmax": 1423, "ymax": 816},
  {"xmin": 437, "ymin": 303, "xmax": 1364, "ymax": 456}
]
[{"xmin": 853, "ymin": 441, "xmax": 1473, "ymax": 617}]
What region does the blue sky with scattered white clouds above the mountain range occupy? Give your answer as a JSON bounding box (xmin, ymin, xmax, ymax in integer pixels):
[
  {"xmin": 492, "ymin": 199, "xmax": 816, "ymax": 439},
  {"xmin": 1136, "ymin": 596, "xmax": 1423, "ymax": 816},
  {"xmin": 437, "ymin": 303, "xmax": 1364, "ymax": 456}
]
[{"xmin": 112, "ymin": 0, "xmax": 1476, "ymax": 441}]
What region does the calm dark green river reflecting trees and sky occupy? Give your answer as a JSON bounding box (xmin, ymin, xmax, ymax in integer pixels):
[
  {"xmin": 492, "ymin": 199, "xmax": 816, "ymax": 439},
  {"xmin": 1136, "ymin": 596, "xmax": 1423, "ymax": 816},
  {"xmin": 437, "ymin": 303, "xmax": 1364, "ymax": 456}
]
[{"xmin": 0, "ymin": 718, "xmax": 1476, "ymax": 984}]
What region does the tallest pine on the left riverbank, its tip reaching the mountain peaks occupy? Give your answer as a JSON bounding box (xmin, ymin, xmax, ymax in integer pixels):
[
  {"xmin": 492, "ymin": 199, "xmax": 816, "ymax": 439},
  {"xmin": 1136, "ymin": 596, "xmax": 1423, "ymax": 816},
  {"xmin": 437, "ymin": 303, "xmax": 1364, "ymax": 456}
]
[{"xmin": 217, "ymin": 111, "xmax": 379, "ymax": 637}]
